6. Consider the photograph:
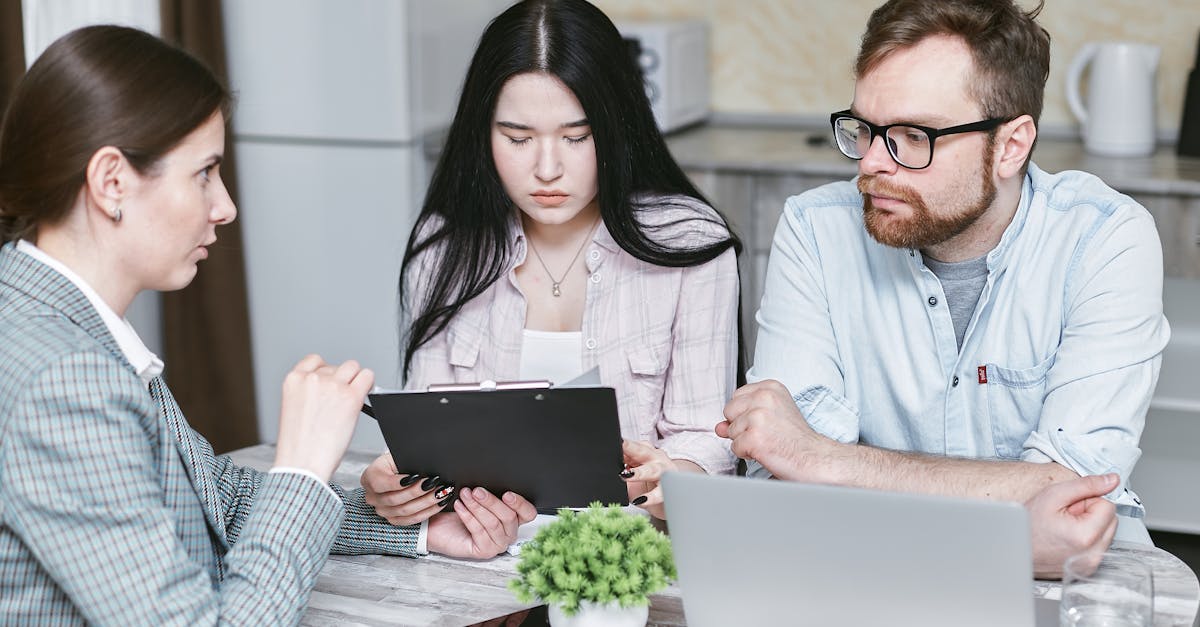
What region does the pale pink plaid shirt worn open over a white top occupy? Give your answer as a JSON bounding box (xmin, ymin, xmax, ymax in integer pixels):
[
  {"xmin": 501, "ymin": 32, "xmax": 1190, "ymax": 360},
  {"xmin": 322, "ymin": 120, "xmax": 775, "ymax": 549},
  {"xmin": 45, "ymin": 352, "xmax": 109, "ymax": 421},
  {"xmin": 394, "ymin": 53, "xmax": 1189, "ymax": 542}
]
[{"xmin": 406, "ymin": 197, "xmax": 738, "ymax": 473}]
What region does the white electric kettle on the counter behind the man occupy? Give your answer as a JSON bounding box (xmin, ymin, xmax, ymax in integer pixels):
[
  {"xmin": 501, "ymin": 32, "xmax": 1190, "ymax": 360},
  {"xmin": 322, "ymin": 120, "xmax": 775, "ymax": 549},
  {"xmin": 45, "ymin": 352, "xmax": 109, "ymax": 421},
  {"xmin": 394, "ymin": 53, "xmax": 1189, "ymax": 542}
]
[{"xmin": 1067, "ymin": 42, "xmax": 1163, "ymax": 156}]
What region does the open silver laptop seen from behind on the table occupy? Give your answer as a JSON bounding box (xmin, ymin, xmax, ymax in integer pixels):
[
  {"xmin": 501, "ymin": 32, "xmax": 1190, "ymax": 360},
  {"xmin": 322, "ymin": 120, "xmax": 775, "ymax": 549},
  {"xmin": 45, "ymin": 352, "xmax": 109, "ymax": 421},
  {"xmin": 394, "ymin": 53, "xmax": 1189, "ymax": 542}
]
[{"xmin": 662, "ymin": 472, "xmax": 1057, "ymax": 627}]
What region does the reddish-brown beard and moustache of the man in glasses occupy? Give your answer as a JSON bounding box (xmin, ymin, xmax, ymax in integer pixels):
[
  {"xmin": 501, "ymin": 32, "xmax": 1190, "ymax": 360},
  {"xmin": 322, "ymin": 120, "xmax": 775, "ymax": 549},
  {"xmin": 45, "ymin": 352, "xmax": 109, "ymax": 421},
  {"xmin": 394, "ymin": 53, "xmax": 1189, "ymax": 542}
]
[{"xmin": 858, "ymin": 142, "xmax": 996, "ymax": 249}]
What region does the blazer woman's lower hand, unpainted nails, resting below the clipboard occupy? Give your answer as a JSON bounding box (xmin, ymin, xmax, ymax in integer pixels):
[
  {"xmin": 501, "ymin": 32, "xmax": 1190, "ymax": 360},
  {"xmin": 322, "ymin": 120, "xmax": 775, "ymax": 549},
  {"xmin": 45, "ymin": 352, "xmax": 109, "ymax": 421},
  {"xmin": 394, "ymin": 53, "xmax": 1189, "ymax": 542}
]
[{"xmin": 428, "ymin": 488, "xmax": 538, "ymax": 560}]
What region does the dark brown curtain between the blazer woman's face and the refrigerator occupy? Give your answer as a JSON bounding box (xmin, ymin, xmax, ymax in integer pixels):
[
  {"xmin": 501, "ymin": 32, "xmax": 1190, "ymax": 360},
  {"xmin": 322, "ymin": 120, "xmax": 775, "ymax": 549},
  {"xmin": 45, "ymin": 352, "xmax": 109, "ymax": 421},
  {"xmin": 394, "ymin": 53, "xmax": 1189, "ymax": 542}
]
[{"xmin": 159, "ymin": 0, "xmax": 259, "ymax": 453}]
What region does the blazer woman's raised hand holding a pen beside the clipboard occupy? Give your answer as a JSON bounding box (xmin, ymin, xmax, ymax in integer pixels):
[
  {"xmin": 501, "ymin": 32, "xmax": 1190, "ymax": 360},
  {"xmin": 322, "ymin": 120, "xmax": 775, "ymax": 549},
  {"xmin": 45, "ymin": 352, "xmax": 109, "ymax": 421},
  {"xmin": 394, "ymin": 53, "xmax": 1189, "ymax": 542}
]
[{"xmin": 275, "ymin": 354, "xmax": 374, "ymax": 483}]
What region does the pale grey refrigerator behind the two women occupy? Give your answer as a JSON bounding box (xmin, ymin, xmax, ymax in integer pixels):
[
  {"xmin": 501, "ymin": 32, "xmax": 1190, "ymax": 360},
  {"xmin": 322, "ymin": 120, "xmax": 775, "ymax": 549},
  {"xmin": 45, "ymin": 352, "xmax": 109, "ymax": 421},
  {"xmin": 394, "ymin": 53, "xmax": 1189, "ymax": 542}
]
[{"xmin": 224, "ymin": 0, "xmax": 509, "ymax": 450}]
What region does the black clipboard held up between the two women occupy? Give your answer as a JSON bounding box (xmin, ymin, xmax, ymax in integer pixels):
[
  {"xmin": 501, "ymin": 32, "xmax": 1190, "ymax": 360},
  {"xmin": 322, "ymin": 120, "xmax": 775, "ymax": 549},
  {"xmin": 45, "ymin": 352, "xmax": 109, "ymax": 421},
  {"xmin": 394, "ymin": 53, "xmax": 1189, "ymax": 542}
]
[{"xmin": 370, "ymin": 382, "xmax": 629, "ymax": 510}]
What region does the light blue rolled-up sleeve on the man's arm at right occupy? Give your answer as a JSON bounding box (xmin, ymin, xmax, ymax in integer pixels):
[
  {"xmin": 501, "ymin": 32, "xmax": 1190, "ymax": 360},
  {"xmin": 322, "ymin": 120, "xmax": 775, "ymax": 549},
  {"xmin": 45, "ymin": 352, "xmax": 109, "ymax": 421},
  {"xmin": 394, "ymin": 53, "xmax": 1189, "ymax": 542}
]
[{"xmin": 1021, "ymin": 211, "xmax": 1170, "ymax": 518}]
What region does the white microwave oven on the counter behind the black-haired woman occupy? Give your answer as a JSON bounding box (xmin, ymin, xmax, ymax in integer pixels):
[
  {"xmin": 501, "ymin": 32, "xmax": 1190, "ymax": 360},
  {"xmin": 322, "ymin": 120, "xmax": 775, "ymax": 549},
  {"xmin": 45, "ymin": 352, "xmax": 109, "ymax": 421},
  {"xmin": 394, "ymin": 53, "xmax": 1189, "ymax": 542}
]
[{"xmin": 617, "ymin": 19, "xmax": 709, "ymax": 133}]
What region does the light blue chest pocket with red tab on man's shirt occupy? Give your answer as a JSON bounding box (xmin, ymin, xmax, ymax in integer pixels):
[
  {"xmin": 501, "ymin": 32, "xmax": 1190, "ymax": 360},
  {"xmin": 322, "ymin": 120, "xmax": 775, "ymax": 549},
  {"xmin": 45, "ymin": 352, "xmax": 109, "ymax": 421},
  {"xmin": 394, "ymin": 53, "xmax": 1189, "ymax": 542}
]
[{"xmin": 986, "ymin": 354, "xmax": 1055, "ymax": 459}]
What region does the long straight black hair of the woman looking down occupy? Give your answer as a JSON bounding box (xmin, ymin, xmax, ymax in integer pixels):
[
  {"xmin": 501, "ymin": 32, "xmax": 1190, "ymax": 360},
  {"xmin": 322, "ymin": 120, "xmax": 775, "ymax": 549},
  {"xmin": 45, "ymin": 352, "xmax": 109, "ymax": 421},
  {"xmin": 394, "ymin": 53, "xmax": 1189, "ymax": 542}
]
[{"xmin": 400, "ymin": 0, "xmax": 744, "ymax": 374}]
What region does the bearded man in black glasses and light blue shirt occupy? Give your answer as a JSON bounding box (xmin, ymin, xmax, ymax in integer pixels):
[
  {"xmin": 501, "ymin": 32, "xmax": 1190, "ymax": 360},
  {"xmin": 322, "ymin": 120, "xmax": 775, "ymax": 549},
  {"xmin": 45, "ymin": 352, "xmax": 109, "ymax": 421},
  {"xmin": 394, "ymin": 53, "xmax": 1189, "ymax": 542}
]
[{"xmin": 716, "ymin": 0, "xmax": 1170, "ymax": 552}]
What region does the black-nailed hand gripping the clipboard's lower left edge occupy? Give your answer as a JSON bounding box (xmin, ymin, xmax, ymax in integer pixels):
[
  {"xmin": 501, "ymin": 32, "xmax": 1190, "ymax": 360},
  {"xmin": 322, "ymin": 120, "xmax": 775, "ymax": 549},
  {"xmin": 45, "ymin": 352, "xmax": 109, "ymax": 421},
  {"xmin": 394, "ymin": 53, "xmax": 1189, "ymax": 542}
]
[{"xmin": 359, "ymin": 453, "xmax": 454, "ymax": 525}]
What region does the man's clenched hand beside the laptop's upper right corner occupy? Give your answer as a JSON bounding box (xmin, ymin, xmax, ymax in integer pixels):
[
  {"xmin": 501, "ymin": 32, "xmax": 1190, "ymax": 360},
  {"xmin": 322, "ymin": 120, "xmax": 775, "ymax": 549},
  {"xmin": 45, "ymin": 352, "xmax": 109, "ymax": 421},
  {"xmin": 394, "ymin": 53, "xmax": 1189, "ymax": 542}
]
[{"xmin": 1025, "ymin": 474, "xmax": 1120, "ymax": 579}]
